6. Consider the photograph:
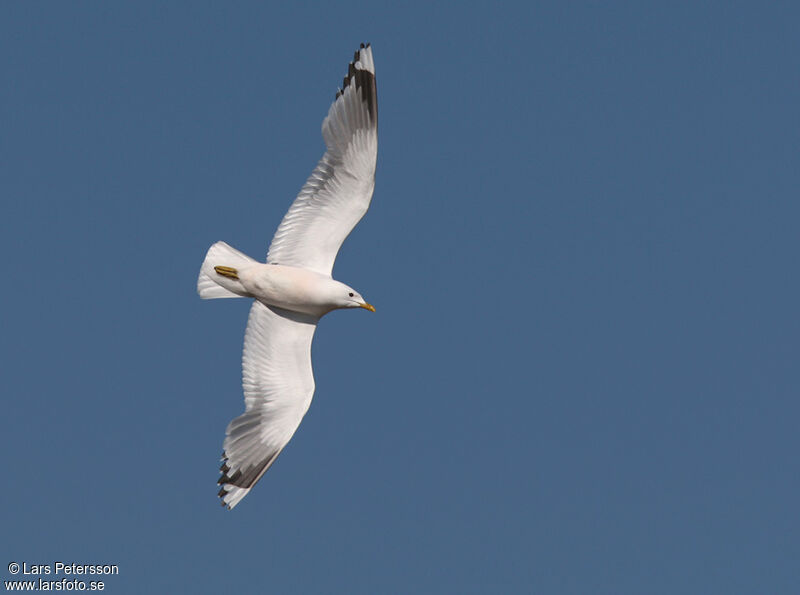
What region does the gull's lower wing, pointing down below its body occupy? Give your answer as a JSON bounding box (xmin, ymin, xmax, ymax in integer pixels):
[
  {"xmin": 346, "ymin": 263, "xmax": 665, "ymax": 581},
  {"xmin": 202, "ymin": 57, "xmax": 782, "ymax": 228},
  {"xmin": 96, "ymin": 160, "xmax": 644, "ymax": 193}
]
[{"xmin": 218, "ymin": 301, "xmax": 319, "ymax": 508}]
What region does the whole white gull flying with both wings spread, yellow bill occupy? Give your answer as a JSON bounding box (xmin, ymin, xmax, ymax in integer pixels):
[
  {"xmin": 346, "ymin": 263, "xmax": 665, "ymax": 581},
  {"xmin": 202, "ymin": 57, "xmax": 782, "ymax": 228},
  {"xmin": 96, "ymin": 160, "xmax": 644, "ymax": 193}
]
[{"xmin": 197, "ymin": 44, "xmax": 378, "ymax": 509}]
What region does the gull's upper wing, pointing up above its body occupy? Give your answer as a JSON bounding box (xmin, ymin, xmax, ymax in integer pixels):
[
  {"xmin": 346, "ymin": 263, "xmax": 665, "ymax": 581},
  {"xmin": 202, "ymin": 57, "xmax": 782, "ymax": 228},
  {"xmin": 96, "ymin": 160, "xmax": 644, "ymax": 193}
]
[{"xmin": 267, "ymin": 44, "xmax": 378, "ymax": 275}]
